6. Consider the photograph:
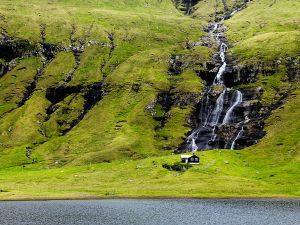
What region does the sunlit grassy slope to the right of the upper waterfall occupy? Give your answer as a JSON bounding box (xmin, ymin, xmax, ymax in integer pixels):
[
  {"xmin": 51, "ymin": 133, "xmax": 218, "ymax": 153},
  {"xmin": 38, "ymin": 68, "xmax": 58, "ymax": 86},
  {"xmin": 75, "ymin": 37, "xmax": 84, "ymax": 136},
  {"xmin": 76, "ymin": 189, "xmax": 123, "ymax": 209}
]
[{"xmin": 226, "ymin": 0, "xmax": 300, "ymax": 103}]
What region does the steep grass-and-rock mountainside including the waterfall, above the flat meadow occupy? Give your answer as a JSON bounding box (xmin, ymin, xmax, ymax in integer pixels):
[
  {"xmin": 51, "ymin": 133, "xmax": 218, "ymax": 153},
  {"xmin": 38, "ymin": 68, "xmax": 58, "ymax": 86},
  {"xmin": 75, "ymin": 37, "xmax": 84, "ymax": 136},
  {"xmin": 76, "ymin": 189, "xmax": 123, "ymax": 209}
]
[{"xmin": 0, "ymin": 0, "xmax": 299, "ymax": 166}]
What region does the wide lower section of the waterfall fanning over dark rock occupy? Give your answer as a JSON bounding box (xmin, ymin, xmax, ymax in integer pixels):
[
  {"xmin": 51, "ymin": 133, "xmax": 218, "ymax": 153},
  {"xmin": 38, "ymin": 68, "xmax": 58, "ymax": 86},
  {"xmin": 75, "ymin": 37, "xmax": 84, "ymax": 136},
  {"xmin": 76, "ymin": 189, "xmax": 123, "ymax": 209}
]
[{"xmin": 185, "ymin": 89, "xmax": 245, "ymax": 152}]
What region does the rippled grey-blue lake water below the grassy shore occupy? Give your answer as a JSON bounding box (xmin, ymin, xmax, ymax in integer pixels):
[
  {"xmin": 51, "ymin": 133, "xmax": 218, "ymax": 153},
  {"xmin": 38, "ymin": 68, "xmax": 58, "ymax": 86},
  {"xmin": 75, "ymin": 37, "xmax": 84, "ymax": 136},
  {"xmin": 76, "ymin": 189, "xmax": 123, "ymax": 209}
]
[{"xmin": 0, "ymin": 199, "xmax": 300, "ymax": 225}]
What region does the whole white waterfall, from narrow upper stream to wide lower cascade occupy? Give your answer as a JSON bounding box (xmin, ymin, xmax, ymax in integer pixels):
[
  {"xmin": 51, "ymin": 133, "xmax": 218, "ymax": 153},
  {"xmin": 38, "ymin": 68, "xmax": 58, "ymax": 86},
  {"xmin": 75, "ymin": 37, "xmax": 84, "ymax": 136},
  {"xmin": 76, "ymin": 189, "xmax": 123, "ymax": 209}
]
[{"xmin": 186, "ymin": 9, "xmax": 244, "ymax": 152}]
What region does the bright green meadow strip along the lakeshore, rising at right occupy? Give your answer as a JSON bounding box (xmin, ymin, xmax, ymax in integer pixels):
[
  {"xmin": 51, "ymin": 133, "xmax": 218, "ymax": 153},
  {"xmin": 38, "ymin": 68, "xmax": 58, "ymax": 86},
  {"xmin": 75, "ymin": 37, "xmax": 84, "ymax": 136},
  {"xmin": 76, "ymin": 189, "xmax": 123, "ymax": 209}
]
[{"xmin": 0, "ymin": 88, "xmax": 300, "ymax": 199}]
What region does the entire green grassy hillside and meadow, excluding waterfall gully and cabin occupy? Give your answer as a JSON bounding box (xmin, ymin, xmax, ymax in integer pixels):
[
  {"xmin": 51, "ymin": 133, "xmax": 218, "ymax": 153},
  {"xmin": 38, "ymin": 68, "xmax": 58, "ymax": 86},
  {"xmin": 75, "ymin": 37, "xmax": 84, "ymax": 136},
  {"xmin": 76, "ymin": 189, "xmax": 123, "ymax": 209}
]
[{"xmin": 0, "ymin": 0, "xmax": 300, "ymax": 199}]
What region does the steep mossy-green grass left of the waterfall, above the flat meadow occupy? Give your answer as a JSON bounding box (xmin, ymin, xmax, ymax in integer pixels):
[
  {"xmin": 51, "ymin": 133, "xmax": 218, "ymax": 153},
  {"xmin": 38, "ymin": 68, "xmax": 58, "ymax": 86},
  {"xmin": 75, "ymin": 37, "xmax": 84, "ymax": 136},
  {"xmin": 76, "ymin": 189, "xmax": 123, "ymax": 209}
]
[{"xmin": 0, "ymin": 0, "xmax": 206, "ymax": 163}]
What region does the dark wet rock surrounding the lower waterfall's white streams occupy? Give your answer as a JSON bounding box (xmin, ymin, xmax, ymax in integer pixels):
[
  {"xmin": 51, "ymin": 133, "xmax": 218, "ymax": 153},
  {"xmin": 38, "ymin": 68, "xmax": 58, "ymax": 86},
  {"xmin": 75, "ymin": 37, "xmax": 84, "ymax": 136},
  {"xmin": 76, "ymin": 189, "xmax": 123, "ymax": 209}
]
[{"xmin": 175, "ymin": 89, "xmax": 272, "ymax": 153}]
